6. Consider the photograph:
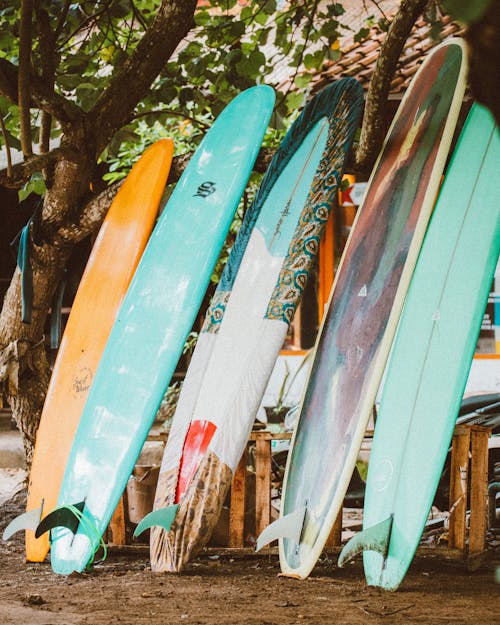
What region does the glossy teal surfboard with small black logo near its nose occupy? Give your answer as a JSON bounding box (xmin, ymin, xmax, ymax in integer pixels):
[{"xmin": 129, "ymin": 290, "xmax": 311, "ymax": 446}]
[{"xmin": 40, "ymin": 86, "xmax": 274, "ymax": 574}]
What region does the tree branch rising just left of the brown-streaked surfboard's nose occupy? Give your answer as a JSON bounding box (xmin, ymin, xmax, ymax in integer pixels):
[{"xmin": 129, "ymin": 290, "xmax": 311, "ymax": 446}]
[{"xmin": 356, "ymin": 0, "xmax": 429, "ymax": 171}]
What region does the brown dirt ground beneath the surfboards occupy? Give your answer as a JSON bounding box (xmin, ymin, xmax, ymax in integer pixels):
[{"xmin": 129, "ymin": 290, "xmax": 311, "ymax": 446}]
[{"xmin": 0, "ymin": 493, "xmax": 500, "ymax": 625}]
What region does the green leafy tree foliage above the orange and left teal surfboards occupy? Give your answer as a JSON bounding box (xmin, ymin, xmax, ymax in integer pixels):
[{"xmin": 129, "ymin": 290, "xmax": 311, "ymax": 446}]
[{"xmin": 0, "ymin": 0, "xmax": 386, "ymax": 195}]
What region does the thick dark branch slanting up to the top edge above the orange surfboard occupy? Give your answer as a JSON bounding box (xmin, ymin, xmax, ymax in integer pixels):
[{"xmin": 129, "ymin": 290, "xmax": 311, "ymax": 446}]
[{"xmin": 91, "ymin": 0, "xmax": 196, "ymax": 154}]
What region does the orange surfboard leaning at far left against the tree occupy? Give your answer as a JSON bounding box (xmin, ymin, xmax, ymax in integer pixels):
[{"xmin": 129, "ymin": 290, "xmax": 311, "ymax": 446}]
[{"xmin": 26, "ymin": 139, "xmax": 173, "ymax": 562}]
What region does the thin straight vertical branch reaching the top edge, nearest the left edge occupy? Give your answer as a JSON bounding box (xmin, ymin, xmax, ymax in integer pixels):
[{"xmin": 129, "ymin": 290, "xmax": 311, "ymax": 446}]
[{"xmin": 17, "ymin": 0, "xmax": 33, "ymax": 158}]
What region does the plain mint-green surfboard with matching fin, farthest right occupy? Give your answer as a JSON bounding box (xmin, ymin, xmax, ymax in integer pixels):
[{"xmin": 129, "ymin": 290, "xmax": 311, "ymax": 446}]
[{"xmin": 339, "ymin": 105, "xmax": 500, "ymax": 590}]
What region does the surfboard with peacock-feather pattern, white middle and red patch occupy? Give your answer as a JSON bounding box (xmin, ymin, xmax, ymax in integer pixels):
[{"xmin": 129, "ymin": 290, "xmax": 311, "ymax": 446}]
[{"xmin": 139, "ymin": 79, "xmax": 362, "ymax": 571}]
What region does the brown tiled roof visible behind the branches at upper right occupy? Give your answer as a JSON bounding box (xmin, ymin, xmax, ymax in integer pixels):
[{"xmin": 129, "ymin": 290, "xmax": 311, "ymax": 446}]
[{"xmin": 313, "ymin": 16, "xmax": 464, "ymax": 97}]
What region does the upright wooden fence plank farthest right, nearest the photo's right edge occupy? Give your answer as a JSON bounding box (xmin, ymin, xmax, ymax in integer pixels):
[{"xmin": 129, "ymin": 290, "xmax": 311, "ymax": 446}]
[{"xmin": 469, "ymin": 426, "xmax": 490, "ymax": 554}]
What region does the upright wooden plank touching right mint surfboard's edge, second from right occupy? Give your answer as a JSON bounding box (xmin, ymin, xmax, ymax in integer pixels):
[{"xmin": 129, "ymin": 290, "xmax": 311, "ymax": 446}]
[{"xmin": 448, "ymin": 426, "xmax": 470, "ymax": 551}]
